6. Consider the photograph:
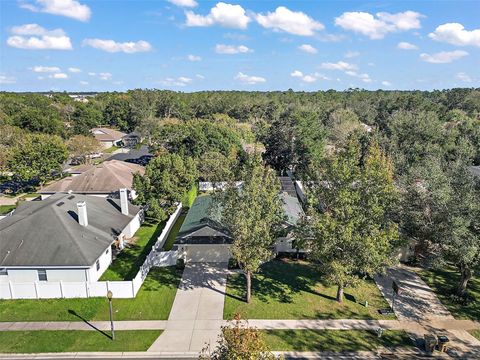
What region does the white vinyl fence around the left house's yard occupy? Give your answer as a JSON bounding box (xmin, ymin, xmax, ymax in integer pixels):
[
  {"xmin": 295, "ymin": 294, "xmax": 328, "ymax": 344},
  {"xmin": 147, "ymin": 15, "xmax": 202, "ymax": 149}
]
[{"xmin": 0, "ymin": 204, "xmax": 182, "ymax": 299}]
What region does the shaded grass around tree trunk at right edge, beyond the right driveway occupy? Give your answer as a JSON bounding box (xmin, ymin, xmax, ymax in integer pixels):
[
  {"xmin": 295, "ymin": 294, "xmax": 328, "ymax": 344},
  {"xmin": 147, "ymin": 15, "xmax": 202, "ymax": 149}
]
[{"xmin": 420, "ymin": 266, "xmax": 480, "ymax": 320}]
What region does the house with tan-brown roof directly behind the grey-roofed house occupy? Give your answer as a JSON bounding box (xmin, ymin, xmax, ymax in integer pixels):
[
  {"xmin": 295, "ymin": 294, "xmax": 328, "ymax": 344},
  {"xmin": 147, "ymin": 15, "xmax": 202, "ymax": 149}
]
[{"xmin": 38, "ymin": 160, "xmax": 145, "ymax": 199}]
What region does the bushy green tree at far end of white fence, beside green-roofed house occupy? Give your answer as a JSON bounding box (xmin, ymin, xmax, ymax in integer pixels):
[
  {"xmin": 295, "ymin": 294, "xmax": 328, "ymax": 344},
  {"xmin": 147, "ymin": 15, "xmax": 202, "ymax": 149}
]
[{"xmin": 133, "ymin": 152, "xmax": 197, "ymax": 221}]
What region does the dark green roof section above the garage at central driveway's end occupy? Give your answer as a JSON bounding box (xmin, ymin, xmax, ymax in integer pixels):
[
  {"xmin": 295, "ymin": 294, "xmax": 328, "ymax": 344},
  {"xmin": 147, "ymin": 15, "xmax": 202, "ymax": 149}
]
[{"xmin": 175, "ymin": 195, "xmax": 232, "ymax": 244}]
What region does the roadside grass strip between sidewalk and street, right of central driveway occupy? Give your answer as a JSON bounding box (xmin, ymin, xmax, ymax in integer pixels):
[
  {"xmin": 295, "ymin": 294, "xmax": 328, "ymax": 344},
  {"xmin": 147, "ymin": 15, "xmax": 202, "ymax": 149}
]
[{"xmin": 262, "ymin": 330, "xmax": 413, "ymax": 352}]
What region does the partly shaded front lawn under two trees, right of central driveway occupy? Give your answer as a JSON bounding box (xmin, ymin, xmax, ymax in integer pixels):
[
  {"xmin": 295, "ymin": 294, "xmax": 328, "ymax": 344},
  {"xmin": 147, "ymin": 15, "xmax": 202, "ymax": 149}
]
[{"xmin": 223, "ymin": 260, "xmax": 394, "ymax": 319}]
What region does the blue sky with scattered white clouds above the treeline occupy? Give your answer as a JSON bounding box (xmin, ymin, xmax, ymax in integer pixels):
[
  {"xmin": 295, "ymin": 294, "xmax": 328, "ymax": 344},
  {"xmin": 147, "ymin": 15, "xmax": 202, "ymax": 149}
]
[{"xmin": 0, "ymin": 0, "xmax": 480, "ymax": 92}]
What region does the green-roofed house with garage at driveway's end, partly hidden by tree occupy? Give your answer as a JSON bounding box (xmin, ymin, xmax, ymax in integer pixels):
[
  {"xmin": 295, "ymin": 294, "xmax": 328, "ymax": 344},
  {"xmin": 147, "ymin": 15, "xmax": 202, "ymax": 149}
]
[{"xmin": 175, "ymin": 180, "xmax": 303, "ymax": 262}]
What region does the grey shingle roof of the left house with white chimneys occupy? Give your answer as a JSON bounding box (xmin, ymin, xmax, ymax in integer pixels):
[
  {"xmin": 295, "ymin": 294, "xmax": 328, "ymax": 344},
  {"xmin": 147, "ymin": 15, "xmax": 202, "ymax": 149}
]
[{"xmin": 0, "ymin": 194, "xmax": 140, "ymax": 267}]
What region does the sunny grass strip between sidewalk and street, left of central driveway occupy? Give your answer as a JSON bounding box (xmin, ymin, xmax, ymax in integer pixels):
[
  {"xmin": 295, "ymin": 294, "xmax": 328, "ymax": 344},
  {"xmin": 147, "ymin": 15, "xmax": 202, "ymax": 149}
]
[{"xmin": 0, "ymin": 330, "xmax": 162, "ymax": 353}]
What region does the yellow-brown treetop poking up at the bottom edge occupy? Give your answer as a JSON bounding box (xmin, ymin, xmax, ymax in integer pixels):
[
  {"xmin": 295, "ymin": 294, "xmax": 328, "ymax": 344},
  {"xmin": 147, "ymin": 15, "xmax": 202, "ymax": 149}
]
[{"xmin": 199, "ymin": 315, "xmax": 278, "ymax": 360}]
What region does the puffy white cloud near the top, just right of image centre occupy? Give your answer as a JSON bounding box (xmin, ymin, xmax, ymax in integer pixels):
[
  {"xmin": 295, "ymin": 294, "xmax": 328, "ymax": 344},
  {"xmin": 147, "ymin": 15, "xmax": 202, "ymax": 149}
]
[{"xmin": 255, "ymin": 6, "xmax": 325, "ymax": 36}]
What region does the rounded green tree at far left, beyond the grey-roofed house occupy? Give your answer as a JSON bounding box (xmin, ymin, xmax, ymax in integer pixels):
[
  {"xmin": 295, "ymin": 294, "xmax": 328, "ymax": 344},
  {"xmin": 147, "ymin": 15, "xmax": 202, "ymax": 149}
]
[{"xmin": 7, "ymin": 134, "xmax": 68, "ymax": 184}]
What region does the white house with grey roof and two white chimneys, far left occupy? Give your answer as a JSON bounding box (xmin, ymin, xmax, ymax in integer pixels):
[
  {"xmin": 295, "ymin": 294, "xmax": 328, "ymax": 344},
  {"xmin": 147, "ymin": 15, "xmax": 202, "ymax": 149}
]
[{"xmin": 0, "ymin": 189, "xmax": 143, "ymax": 283}]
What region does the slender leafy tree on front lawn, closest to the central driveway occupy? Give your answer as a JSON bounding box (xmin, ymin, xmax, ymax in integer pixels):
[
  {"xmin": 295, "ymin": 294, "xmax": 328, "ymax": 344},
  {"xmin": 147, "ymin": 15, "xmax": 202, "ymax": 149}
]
[{"xmin": 217, "ymin": 154, "xmax": 284, "ymax": 302}]
